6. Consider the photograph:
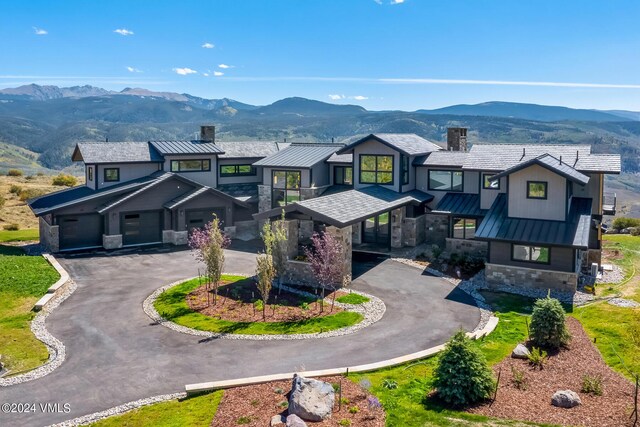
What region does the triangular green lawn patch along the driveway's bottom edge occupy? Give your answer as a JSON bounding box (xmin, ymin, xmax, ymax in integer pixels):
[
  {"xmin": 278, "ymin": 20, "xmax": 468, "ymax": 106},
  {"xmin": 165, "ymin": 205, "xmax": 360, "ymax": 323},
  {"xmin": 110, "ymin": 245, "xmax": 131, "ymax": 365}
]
[{"xmin": 91, "ymin": 391, "xmax": 223, "ymax": 427}]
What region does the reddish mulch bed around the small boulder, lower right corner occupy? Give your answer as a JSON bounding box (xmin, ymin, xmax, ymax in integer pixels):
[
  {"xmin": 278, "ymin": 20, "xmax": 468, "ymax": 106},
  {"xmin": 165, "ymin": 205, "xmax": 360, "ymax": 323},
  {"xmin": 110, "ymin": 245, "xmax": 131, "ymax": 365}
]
[{"xmin": 469, "ymin": 318, "xmax": 634, "ymax": 427}]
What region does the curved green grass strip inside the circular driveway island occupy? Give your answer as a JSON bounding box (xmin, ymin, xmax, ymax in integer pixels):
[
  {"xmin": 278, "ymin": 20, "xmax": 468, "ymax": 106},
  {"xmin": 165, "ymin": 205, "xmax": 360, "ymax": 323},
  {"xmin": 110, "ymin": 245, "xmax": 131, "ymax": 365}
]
[{"xmin": 154, "ymin": 275, "xmax": 363, "ymax": 335}]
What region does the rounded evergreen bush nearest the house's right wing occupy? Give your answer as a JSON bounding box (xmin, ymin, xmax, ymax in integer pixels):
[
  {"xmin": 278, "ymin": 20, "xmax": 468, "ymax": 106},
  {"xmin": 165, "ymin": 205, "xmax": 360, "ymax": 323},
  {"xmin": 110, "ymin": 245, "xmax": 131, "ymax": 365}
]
[{"xmin": 530, "ymin": 296, "xmax": 571, "ymax": 350}]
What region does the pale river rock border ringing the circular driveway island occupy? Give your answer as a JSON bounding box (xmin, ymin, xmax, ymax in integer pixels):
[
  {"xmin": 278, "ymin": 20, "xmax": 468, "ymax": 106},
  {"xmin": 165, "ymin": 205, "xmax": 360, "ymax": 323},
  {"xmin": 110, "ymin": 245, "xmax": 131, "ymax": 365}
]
[{"xmin": 142, "ymin": 273, "xmax": 387, "ymax": 341}]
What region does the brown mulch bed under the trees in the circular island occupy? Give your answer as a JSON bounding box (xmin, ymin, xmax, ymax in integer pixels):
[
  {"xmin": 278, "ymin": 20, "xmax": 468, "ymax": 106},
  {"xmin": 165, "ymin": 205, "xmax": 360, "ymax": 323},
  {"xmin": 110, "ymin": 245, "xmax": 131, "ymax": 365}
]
[{"xmin": 187, "ymin": 279, "xmax": 343, "ymax": 322}]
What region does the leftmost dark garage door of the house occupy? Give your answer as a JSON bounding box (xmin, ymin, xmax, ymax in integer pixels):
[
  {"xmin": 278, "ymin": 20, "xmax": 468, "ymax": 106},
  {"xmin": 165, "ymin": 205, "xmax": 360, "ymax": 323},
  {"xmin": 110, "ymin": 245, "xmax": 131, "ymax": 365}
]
[{"xmin": 57, "ymin": 214, "xmax": 104, "ymax": 250}]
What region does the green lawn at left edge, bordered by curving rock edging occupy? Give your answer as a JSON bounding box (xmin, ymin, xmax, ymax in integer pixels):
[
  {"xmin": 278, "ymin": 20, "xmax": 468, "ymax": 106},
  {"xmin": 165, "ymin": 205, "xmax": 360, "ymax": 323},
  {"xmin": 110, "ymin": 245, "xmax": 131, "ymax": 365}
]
[{"xmin": 0, "ymin": 245, "xmax": 60, "ymax": 373}]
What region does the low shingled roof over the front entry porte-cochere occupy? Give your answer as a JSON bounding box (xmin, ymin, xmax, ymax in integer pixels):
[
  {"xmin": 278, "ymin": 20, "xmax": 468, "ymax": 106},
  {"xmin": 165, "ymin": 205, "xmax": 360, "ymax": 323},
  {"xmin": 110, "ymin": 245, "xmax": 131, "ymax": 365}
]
[{"xmin": 254, "ymin": 186, "xmax": 433, "ymax": 227}]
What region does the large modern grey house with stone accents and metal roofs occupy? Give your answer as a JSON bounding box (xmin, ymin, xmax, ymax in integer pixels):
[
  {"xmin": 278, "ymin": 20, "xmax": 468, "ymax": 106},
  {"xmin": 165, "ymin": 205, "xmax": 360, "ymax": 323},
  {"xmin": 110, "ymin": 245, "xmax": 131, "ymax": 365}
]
[{"xmin": 29, "ymin": 126, "xmax": 620, "ymax": 291}]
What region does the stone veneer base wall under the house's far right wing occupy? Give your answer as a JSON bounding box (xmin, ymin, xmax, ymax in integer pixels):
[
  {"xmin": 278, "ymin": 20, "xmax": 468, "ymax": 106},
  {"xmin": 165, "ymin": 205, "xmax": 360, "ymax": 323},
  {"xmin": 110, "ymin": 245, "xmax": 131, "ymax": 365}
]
[{"xmin": 485, "ymin": 264, "xmax": 578, "ymax": 292}]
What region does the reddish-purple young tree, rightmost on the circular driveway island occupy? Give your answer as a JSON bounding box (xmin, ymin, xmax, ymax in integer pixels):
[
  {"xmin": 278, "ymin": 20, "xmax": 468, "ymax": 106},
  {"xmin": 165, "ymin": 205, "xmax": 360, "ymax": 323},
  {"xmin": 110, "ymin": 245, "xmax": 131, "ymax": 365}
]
[{"xmin": 304, "ymin": 232, "xmax": 344, "ymax": 312}]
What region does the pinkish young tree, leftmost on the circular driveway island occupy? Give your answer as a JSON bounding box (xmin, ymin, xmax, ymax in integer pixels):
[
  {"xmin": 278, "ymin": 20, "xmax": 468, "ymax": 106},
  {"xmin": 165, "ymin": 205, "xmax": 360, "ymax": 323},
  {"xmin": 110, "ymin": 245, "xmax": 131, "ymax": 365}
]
[{"xmin": 189, "ymin": 216, "xmax": 231, "ymax": 305}]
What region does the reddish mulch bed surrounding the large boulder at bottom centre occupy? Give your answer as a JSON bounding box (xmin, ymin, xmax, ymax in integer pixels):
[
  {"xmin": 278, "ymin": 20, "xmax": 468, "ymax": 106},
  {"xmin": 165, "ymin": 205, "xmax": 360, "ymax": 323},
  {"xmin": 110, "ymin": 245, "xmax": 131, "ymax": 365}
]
[{"xmin": 211, "ymin": 376, "xmax": 386, "ymax": 427}]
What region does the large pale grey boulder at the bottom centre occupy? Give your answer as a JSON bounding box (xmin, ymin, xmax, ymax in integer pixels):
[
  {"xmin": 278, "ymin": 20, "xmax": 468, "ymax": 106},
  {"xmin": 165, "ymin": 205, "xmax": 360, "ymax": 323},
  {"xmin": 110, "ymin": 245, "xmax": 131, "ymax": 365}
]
[{"xmin": 289, "ymin": 375, "xmax": 336, "ymax": 421}]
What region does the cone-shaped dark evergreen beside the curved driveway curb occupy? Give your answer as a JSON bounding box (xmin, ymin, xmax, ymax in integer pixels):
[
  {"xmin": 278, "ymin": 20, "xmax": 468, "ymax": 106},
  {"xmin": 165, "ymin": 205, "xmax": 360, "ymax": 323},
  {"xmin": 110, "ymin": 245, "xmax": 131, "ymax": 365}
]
[{"xmin": 433, "ymin": 330, "xmax": 495, "ymax": 406}]
